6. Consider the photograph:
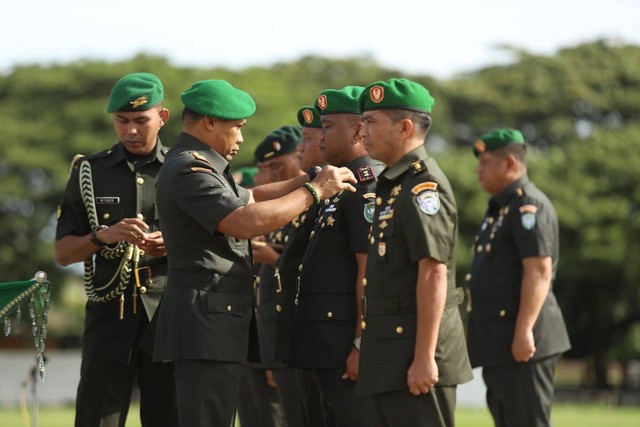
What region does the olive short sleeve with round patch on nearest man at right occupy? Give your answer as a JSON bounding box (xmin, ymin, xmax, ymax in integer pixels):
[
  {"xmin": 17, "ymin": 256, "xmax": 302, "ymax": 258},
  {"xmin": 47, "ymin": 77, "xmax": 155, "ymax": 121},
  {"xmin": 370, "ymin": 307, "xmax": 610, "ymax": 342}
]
[{"xmin": 397, "ymin": 178, "xmax": 458, "ymax": 264}]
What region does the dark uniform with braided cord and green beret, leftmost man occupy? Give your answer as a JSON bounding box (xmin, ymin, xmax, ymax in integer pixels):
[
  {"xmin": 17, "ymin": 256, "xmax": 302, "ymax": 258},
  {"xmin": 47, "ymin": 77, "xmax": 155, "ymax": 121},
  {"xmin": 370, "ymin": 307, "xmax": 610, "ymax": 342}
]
[{"xmin": 56, "ymin": 73, "xmax": 177, "ymax": 427}]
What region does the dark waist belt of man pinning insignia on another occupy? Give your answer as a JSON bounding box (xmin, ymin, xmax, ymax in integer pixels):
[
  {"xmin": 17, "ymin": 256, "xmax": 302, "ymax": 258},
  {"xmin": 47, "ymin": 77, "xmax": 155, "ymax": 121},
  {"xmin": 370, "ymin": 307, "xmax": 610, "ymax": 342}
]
[{"xmin": 167, "ymin": 270, "xmax": 255, "ymax": 295}]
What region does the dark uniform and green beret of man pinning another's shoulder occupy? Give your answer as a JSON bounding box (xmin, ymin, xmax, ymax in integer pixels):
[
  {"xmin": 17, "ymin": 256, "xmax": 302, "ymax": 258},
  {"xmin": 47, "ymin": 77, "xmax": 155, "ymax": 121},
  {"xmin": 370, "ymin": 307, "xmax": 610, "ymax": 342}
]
[{"xmin": 154, "ymin": 80, "xmax": 257, "ymax": 426}]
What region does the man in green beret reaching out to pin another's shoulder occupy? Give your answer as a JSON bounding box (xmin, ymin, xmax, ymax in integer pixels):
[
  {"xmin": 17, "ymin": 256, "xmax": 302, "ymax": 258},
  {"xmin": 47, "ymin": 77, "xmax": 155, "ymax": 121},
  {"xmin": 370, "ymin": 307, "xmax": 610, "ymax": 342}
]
[{"xmin": 154, "ymin": 80, "xmax": 355, "ymax": 427}]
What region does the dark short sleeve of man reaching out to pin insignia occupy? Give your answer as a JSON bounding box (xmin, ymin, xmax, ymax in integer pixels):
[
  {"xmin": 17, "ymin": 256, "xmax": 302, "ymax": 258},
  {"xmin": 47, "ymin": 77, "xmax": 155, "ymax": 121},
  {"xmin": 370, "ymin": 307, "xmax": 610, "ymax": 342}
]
[{"xmin": 175, "ymin": 170, "xmax": 245, "ymax": 233}]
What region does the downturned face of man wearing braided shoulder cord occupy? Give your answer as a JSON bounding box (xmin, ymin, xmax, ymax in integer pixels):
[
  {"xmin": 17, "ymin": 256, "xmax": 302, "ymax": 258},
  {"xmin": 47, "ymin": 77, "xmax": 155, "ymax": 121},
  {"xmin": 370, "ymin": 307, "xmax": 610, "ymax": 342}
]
[{"xmin": 112, "ymin": 105, "xmax": 169, "ymax": 156}]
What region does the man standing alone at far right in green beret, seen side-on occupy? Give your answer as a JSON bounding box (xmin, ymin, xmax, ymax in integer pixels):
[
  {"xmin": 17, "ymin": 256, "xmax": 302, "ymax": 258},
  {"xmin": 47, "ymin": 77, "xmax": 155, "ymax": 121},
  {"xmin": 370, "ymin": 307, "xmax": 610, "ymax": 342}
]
[{"xmin": 467, "ymin": 129, "xmax": 570, "ymax": 427}]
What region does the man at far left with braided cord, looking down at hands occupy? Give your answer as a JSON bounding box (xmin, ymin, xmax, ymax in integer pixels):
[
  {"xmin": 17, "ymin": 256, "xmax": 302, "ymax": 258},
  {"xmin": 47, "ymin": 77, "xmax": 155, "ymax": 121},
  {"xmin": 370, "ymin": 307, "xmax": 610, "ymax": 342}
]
[{"xmin": 55, "ymin": 73, "xmax": 177, "ymax": 427}]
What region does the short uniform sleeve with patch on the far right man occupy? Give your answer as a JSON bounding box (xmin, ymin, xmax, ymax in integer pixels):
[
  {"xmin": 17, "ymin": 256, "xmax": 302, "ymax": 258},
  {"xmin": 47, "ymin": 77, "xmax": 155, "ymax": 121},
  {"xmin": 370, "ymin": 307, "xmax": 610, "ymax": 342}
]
[{"xmin": 508, "ymin": 198, "xmax": 557, "ymax": 259}]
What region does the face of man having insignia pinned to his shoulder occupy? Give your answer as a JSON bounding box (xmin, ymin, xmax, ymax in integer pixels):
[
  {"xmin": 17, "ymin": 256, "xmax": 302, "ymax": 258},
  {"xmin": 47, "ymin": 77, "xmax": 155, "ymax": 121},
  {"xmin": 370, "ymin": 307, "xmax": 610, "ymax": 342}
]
[{"xmin": 320, "ymin": 114, "xmax": 358, "ymax": 166}]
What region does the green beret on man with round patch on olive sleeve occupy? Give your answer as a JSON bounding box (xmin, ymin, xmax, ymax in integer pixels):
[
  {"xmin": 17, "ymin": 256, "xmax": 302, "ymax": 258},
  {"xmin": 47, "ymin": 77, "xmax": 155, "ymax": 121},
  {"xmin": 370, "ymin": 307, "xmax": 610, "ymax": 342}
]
[{"xmin": 359, "ymin": 78, "xmax": 436, "ymax": 113}]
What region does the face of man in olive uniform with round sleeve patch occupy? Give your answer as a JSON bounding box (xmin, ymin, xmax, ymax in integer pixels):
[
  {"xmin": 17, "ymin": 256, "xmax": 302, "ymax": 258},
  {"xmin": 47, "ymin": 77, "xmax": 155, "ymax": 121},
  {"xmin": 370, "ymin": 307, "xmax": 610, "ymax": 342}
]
[{"xmin": 360, "ymin": 110, "xmax": 397, "ymax": 164}]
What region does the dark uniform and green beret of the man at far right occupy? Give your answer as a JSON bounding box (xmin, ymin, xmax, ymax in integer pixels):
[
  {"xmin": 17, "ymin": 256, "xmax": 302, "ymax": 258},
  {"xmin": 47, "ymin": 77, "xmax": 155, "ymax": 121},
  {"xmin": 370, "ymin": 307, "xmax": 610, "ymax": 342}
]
[{"xmin": 467, "ymin": 131, "xmax": 570, "ymax": 427}]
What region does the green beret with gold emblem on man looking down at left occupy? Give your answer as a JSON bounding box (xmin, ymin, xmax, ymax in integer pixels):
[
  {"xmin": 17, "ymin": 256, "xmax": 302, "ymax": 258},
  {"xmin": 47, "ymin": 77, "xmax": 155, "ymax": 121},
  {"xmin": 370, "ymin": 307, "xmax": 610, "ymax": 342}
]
[{"xmin": 107, "ymin": 73, "xmax": 164, "ymax": 113}]
